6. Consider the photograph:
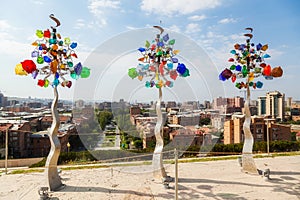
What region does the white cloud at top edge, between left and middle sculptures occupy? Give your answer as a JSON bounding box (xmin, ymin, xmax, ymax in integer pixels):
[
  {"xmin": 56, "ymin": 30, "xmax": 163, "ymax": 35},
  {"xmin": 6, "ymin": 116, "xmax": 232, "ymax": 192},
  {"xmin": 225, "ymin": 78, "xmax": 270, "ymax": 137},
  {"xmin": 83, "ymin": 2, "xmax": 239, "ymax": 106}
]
[{"xmin": 88, "ymin": 0, "xmax": 121, "ymax": 27}]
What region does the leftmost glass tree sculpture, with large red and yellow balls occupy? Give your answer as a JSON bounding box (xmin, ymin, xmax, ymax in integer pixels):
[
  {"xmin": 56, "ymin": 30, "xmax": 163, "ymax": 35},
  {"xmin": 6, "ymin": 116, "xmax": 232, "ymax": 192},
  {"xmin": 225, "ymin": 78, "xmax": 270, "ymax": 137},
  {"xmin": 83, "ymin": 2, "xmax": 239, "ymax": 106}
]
[{"xmin": 15, "ymin": 14, "xmax": 90, "ymax": 191}]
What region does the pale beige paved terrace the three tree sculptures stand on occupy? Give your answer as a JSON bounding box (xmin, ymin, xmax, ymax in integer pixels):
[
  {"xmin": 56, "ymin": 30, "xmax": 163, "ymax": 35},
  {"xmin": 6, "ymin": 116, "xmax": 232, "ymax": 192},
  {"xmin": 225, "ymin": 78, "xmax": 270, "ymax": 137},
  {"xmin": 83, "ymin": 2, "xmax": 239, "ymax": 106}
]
[{"xmin": 0, "ymin": 156, "xmax": 300, "ymax": 200}]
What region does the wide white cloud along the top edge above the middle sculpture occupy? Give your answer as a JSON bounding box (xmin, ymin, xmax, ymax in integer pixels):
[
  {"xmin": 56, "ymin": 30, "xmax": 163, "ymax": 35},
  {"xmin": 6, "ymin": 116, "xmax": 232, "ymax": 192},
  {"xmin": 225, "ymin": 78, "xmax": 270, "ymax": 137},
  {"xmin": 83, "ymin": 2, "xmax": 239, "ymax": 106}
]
[{"xmin": 141, "ymin": 0, "xmax": 221, "ymax": 16}]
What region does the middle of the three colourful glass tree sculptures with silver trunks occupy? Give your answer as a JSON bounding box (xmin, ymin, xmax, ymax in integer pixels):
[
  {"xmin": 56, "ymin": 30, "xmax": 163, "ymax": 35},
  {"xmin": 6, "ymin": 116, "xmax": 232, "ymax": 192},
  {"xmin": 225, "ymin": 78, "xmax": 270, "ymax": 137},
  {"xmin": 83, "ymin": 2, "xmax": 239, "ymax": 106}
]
[{"xmin": 128, "ymin": 26, "xmax": 190, "ymax": 178}]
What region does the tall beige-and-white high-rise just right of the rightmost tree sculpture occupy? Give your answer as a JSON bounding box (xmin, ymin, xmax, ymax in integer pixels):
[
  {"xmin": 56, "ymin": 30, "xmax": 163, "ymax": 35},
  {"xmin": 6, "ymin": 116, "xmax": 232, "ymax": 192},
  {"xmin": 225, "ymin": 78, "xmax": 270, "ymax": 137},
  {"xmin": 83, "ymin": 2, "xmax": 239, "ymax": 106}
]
[{"xmin": 258, "ymin": 91, "xmax": 285, "ymax": 121}]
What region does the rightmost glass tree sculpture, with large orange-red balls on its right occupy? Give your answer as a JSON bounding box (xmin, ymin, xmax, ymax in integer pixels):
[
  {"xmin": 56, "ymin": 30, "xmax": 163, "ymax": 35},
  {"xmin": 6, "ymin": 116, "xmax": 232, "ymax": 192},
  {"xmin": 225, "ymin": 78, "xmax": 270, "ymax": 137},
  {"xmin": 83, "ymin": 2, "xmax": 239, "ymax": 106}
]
[{"xmin": 219, "ymin": 28, "xmax": 283, "ymax": 174}]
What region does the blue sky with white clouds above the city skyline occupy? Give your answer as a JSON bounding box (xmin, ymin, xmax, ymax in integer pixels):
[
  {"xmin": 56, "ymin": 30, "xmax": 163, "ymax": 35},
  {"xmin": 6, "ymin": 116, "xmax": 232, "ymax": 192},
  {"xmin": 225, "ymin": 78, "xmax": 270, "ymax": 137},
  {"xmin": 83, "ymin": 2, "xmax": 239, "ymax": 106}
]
[{"xmin": 0, "ymin": 0, "xmax": 300, "ymax": 101}]
